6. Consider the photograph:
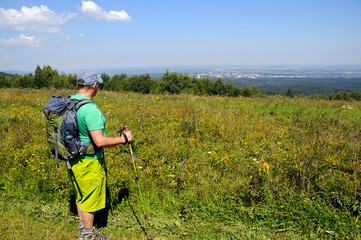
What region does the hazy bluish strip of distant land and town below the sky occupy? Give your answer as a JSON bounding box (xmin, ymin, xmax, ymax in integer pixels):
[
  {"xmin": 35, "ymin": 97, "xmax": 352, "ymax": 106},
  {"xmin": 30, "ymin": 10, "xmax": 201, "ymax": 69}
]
[{"xmin": 0, "ymin": 65, "xmax": 361, "ymax": 79}]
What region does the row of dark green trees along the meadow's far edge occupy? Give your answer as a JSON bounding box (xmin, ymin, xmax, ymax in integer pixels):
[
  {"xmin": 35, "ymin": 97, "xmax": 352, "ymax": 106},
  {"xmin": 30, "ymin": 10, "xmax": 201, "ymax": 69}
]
[{"xmin": 0, "ymin": 65, "xmax": 361, "ymax": 101}]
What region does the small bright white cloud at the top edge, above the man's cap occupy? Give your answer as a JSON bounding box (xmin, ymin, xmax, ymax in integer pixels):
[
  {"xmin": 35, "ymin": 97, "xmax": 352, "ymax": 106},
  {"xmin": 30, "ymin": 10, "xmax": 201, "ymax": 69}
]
[{"xmin": 81, "ymin": 1, "xmax": 133, "ymax": 22}]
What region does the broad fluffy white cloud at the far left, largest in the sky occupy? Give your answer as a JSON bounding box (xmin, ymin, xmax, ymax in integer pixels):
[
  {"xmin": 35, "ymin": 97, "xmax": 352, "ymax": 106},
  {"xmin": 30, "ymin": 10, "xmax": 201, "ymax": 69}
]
[{"xmin": 0, "ymin": 5, "xmax": 76, "ymax": 33}]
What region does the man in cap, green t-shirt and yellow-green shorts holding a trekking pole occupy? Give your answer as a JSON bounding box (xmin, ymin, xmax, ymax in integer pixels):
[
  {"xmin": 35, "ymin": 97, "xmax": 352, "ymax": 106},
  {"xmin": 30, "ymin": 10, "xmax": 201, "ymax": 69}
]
[{"xmin": 69, "ymin": 72, "xmax": 132, "ymax": 240}]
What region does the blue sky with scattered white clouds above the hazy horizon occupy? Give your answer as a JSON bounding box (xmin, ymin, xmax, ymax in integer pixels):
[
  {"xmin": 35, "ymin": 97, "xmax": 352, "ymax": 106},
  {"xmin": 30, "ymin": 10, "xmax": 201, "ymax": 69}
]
[{"xmin": 0, "ymin": 0, "xmax": 361, "ymax": 72}]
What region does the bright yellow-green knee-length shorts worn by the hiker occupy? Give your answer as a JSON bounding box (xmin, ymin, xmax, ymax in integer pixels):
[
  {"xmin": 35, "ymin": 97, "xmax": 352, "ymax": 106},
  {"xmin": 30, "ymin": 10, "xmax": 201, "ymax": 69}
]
[{"xmin": 68, "ymin": 157, "xmax": 106, "ymax": 212}]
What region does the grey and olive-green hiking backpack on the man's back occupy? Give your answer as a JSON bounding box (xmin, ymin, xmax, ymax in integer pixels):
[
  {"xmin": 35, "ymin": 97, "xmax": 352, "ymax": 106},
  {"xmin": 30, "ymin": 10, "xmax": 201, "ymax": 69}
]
[{"xmin": 43, "ymin": 96, "xmax": 100, "ymax": 169}]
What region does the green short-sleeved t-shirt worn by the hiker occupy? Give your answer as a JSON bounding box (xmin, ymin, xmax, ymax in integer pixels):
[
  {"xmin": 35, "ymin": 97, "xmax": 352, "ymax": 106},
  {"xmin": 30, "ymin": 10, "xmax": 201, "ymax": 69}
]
[{"xmin": 71, "ymin": 93, "xmax": 107, "ymax": 159}]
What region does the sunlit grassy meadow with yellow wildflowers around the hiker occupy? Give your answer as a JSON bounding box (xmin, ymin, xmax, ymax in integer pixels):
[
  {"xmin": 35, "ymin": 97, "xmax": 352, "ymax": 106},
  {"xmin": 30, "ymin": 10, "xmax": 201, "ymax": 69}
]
[{"xmin": 0, "ymin": 89, "xmax": 361, "ymax": 239}]
